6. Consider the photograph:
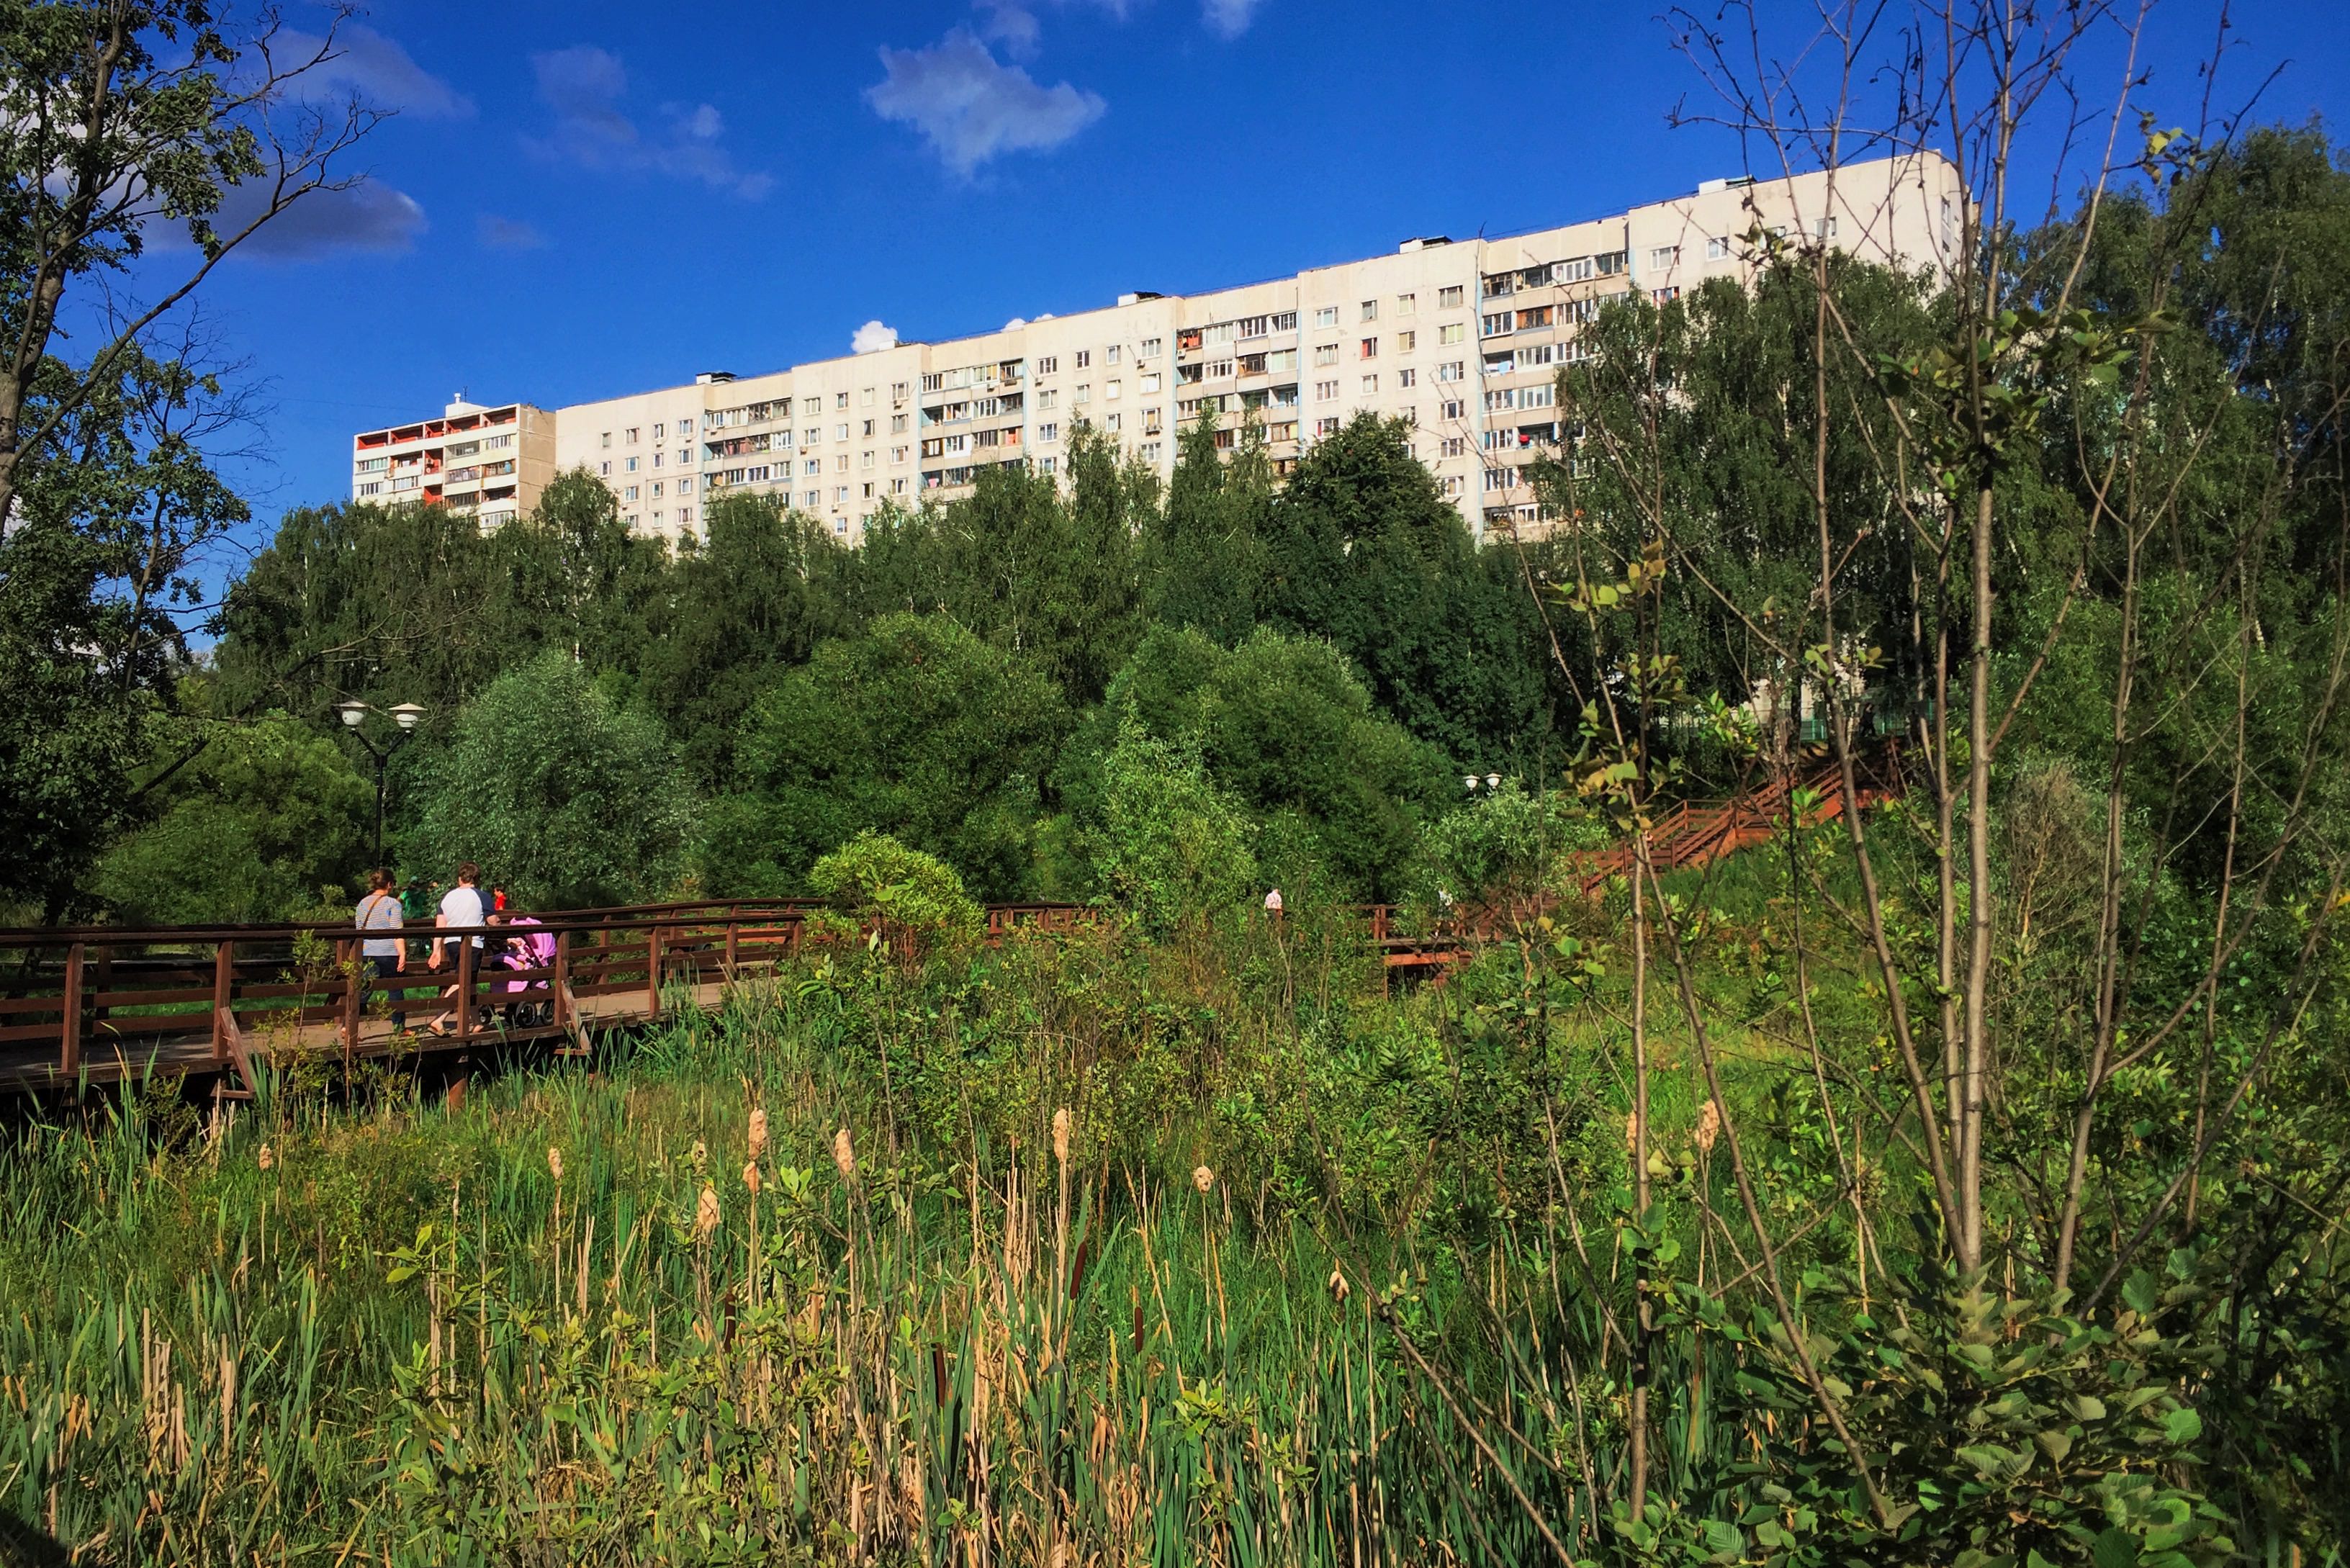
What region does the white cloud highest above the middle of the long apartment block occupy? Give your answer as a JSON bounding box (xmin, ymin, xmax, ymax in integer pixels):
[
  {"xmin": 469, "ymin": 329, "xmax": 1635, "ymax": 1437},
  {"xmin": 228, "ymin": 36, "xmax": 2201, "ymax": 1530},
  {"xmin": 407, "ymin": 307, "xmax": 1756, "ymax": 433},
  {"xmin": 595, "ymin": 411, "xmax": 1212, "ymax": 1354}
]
[{"xmin": 865, "ymin": 28, "xmax": 1107, "ymax": 176}]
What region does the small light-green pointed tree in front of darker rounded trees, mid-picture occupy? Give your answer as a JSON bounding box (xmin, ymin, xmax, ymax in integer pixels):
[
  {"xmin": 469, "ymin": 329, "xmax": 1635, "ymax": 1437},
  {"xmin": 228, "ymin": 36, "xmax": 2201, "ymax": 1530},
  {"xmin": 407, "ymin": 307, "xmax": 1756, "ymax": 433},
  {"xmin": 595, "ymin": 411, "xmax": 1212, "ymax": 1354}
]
[{"xmin": 1097, "ymin": 715, "xmax": 1257, "ymax": 931}]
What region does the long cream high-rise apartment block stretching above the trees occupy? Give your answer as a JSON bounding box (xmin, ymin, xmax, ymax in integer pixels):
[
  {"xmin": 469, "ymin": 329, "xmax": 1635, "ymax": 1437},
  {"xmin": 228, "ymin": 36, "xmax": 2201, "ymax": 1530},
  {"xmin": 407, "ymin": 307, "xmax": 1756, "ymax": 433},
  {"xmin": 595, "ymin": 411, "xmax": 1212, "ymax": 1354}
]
[{"xmin": 353, "ymin": 156, "xmax": 1962, "ymax": 541}]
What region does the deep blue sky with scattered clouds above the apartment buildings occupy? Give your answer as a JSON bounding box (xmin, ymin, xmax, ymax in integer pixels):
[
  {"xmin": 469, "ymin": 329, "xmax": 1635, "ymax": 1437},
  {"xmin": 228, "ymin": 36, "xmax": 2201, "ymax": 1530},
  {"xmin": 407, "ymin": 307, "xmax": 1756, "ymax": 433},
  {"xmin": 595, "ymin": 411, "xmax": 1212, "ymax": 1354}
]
[{"xmin": 170, "ymin": 0, "xmax": 2350, "ymax": 524}]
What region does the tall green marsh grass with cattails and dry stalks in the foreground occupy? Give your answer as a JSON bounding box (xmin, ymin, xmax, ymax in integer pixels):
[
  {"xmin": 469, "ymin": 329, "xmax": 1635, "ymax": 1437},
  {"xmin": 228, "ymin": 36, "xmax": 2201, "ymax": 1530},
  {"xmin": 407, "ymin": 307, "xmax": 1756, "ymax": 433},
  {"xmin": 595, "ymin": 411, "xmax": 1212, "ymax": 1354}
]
[{"xmin": 0, "ymin": 926, "xmax": 1767, "ymax": 1566}]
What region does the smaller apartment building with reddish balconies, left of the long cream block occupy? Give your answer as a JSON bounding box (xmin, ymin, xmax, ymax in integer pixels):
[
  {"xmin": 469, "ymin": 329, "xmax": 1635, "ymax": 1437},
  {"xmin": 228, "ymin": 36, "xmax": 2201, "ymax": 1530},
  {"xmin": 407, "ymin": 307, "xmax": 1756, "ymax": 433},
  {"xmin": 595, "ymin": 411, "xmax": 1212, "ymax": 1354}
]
[{"xmin": 350, "ymin": 395, "xmax": 557, "ymax": 529}]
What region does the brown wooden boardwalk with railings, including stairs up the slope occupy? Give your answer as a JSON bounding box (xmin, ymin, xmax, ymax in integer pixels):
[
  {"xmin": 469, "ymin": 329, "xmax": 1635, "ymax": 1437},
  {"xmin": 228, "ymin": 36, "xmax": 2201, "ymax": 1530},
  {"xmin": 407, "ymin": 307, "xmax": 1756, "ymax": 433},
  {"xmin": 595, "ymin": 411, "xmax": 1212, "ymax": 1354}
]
[{"xmin": 0, "ymin": 776, "xmax": 1887, "ymax": 1096}]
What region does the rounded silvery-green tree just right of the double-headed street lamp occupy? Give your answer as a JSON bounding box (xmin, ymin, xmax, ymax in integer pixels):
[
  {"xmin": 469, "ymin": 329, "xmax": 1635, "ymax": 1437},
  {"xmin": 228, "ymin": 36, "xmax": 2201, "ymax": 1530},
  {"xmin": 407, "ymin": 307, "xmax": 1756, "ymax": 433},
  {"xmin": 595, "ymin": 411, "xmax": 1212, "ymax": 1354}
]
[{"xmin": 402, "ymin": 652, "xmax": 693, "ymax": 910}]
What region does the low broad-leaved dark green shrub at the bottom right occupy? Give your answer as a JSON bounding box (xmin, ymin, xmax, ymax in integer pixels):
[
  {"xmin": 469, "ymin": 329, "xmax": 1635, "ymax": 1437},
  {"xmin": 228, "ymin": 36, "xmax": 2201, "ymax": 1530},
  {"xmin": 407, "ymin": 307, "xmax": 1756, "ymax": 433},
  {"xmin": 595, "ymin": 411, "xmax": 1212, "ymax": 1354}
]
[{"xmin": 1619, "ymin": 1276, "xmax": 2237, "ymax": 1568}]
